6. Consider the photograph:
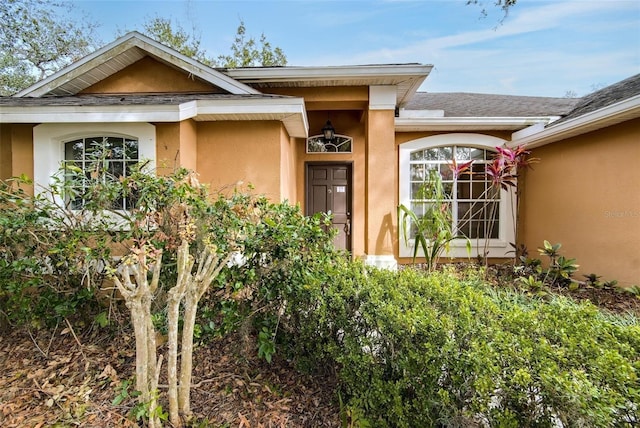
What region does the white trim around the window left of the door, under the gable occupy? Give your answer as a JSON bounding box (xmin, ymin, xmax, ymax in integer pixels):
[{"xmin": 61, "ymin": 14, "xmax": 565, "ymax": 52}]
[{"xmin": 33, "ymin": 123, "xmax": 156, "ymax": 202}]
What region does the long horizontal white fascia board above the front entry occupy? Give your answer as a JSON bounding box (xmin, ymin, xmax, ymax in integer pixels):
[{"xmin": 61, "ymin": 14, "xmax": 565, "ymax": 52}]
[{"xmin": 225, "ymin": 64, "xmax": 433, "ymax": 82}]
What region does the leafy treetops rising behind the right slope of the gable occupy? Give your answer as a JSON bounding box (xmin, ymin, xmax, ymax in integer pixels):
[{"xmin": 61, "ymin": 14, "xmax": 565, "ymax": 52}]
[{"xmin": 143, "ymin": 17, "xmax": 287, "ymax": 68}]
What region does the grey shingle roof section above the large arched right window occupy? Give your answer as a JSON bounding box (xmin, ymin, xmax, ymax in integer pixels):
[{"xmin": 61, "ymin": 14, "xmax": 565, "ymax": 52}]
[{"xmin": 405, "ymin": 92, "xmax": 579, "ymax": 117}]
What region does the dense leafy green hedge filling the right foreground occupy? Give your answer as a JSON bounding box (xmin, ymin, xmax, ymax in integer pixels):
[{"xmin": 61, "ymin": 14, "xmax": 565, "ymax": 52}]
[{"xmin": 288, "ymin": 264, "xmax": 640, "ymax": 427}]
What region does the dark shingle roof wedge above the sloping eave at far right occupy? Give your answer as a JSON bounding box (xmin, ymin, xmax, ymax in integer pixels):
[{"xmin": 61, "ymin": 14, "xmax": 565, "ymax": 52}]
[{"xmin": 550, "ymin": 74, "xmax": 640, "ymax": 126}]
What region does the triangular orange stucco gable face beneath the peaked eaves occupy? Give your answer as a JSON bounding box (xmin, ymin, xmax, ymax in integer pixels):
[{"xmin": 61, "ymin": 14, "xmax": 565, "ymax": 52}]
[{"xmin": 80, "ymin": 56, "xmax": 227, "ymax": 94}]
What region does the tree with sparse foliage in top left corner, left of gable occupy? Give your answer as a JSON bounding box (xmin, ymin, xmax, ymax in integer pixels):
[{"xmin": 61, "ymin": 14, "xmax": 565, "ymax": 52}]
[{"xmin": 0, "ymin": 0, "xmax": 97, "ymax": 95}]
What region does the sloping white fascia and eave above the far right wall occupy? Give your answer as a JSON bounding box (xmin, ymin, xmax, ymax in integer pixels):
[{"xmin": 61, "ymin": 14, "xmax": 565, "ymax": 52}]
[{"xmin": 508, "ymin": 95, "xmax": 640, "ymax": 149}]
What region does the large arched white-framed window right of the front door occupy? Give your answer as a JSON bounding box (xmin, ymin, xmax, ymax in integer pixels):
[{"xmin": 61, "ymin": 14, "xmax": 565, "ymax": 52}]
[{"xmin": 399, "ymin": 134, "xmax": 515, "ymax": 257}]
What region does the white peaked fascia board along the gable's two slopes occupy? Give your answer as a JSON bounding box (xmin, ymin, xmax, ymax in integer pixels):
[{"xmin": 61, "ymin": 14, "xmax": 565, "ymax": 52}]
[{"xmin": 14, "ymin": 31, "xmax": 260, "ymax": 97}]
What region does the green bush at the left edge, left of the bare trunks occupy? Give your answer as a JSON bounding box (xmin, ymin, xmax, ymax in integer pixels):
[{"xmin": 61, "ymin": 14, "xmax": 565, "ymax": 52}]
[{"xmin": 0, "ymin": 178, "xmax": 108, "ymax": 327}]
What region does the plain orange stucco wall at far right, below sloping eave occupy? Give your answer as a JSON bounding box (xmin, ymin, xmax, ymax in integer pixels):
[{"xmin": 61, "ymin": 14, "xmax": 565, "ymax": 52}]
[{"xmin": 519, "ymin": 119, "xmax": 640, "ymax": 286}]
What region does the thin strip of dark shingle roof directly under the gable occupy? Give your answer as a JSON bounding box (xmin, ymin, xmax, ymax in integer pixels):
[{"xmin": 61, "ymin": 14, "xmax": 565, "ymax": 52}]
[{"xmin": 0, "ymin": 94, "xmax": 291, "ymax": 107}]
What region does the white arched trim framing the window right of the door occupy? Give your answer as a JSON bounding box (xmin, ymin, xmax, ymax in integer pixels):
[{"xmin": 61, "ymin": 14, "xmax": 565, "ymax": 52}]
[{"xmin": 398, "ymin": 133, "xmax": 515, "ymax": 258}]
